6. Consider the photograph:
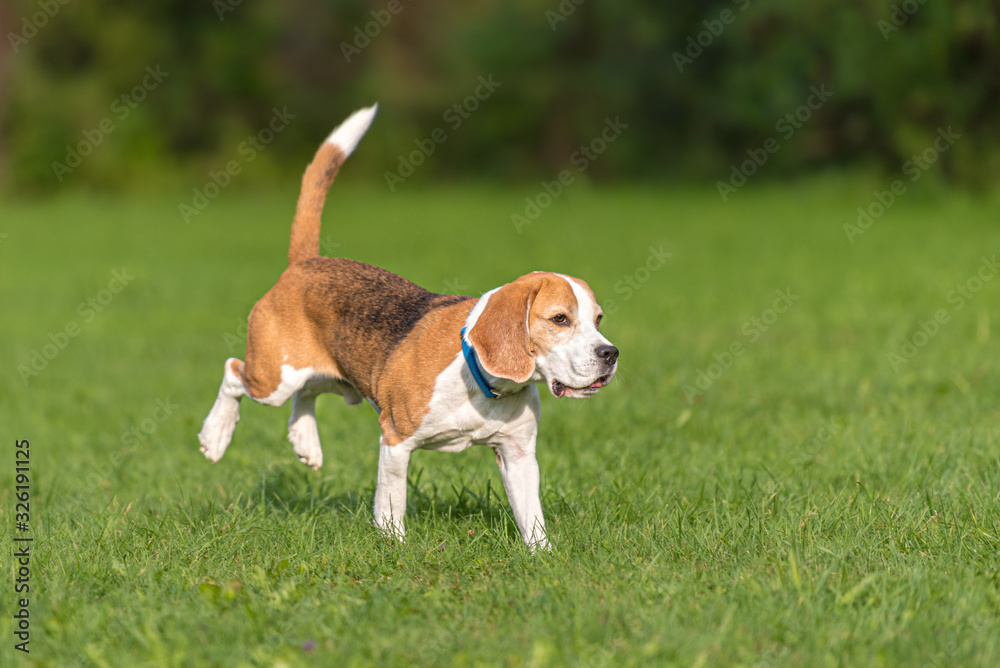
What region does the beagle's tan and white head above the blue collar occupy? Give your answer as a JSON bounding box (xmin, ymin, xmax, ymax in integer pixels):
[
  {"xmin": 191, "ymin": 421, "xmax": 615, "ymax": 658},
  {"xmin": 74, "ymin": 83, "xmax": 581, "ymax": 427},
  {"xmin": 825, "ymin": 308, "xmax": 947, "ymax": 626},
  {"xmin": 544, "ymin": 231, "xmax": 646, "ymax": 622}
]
[{"xmin": 466, "ymin": 271, "xmax": 618, "ymax": 398}]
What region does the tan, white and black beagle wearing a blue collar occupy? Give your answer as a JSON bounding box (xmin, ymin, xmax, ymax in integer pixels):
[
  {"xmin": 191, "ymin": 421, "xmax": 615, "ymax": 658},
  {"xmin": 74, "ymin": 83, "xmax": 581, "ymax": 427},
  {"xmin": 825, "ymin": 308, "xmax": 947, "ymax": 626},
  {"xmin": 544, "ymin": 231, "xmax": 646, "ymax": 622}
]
[{"xmin": 198, "ymin": 105, "xmax": 618, "ymax": 549}]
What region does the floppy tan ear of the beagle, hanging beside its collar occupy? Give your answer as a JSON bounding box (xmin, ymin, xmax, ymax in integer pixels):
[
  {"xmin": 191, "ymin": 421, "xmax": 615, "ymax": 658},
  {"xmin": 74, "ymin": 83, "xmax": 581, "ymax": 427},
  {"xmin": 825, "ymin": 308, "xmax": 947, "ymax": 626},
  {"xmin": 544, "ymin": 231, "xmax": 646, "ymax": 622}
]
[{"xmin": 468, "ymin": 280, "xmax": 541, "ymax": 383}]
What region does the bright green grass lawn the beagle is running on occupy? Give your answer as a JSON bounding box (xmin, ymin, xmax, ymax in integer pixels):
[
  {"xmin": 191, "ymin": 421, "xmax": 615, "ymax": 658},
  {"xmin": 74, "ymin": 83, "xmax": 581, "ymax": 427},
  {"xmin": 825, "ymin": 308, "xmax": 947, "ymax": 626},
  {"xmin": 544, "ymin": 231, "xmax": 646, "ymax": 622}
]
[{"xmin": 0, "ymin": 180, "xmax": 1000, "ymax": 668}]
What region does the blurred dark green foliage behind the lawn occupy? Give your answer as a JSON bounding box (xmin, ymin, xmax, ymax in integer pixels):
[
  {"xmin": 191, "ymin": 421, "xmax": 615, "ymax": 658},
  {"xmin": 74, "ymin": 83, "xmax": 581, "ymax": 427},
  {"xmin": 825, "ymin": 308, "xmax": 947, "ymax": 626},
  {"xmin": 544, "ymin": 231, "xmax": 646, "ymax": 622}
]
[{"xmin": 0, "ymin": 0, "xmax": 1000, "ymax": 191}]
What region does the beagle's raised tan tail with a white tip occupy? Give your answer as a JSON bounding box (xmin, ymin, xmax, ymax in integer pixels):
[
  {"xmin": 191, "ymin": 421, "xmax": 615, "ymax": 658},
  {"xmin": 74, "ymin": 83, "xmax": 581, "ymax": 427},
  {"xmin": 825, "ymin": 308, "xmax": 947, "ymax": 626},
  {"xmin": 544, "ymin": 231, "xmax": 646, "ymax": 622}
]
[{"xmin": 288, "ymin": 104, "xmax": 378, "ymax": 265}]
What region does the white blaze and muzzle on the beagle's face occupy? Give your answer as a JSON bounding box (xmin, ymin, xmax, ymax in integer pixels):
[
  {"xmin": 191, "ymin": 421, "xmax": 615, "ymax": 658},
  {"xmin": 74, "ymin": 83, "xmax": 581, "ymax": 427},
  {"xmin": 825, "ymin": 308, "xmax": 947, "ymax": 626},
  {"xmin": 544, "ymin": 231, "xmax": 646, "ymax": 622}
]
[{"xmin": 535, "ymin": 274, "xmax": 615, "ymax": 396}]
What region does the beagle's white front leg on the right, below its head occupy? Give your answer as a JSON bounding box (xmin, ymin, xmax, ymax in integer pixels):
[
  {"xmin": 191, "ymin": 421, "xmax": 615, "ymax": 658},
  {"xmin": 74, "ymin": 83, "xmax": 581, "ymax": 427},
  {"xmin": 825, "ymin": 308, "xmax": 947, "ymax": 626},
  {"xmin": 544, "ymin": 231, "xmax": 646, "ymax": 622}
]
[{"xmin": 496, "ymin": 438, "xmax": 549, "ymax": 551}]
